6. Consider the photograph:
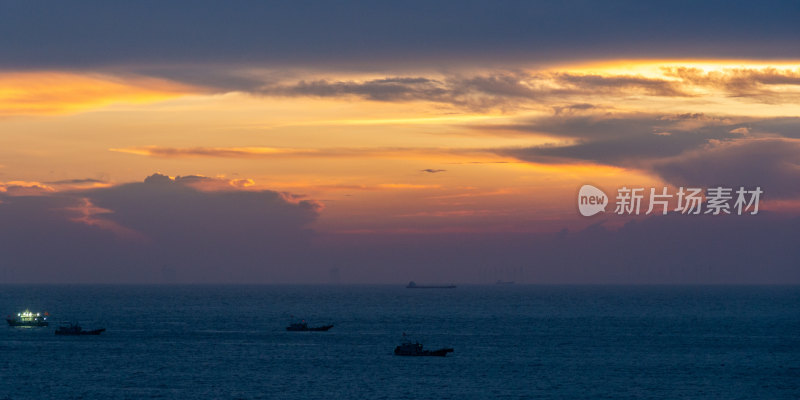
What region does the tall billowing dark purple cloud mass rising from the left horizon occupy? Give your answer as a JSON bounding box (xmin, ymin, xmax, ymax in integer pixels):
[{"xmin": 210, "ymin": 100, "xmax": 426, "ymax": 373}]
[{"xmin": 0, "ymin": 174, "xmax": 320, "ymax": 282}]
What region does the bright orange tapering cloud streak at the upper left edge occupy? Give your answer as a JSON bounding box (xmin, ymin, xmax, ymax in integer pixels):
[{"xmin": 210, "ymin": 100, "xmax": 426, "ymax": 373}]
[{"xmin": 0, "ymin": 72, "xmax": 198, "ymax": 117}]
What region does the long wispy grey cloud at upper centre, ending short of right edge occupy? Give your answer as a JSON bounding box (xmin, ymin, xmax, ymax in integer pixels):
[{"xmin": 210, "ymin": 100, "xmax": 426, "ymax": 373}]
[{"xmin": 256, "ymin": 71, "xmax": 687, "ymax": 111}]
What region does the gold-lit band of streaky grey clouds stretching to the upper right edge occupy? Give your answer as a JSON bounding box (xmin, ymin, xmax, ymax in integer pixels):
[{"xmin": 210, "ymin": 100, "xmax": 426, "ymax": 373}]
[{"xmin": 238, "ymin": 67, "xmax": 800, "ymax": 114}]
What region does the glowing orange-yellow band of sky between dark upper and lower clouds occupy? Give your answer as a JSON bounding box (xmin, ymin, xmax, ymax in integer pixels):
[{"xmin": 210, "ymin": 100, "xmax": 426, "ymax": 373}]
[{"xmin": 0, "ymin": 59, "xmax": 800, "ymax": 236}]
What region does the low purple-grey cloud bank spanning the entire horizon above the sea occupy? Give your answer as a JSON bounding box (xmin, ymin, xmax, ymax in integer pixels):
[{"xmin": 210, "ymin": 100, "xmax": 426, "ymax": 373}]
[{"xmin": 0, "ymin": 174, "xmax": 800, "ymax": 284}]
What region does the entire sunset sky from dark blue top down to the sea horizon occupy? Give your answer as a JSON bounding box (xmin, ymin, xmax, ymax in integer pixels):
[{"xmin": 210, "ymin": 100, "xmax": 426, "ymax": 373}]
[{"xmin": 0, "ymin": 1, "xmax": 800, "ymax": 283}]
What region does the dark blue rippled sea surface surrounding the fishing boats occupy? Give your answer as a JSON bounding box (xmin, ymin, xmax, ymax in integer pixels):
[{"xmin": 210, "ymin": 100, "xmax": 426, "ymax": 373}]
[{"xmin": 0, "ymin": 285, "xmax": 800, "ymax": 399}]
